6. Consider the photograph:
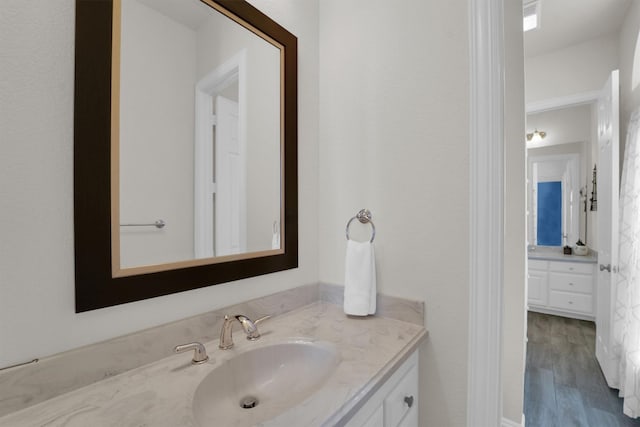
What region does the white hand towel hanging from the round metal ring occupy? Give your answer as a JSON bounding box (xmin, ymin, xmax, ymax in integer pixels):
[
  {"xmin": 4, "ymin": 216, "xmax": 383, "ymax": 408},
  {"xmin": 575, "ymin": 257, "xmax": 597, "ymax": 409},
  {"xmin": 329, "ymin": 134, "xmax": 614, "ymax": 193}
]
[{"xmin": 344, "ymin": 240, "xmax": 377, "ymax": 316}]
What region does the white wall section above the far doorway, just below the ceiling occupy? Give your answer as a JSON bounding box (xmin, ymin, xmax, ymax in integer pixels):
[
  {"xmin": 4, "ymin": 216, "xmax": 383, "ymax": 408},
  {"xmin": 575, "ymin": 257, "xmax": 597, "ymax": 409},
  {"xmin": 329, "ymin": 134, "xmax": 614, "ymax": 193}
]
[{"xmin": 525, "ymin": 34, "xmax": 618, "ymax": 103}]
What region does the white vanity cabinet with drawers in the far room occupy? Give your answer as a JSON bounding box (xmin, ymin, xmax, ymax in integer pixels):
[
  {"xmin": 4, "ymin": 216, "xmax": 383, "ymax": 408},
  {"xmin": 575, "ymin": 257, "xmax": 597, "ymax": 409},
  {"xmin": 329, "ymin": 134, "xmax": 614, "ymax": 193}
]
[{"xmin": 528, "ymin": 259, "xmax": 596, "ymax": 320}]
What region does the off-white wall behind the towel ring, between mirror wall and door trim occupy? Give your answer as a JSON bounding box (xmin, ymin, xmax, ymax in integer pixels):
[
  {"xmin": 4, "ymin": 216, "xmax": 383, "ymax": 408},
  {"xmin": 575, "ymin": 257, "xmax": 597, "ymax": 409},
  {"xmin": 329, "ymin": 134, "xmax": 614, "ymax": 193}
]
[{"xmin": 319, "ymin": 0, "xmax": 470, "ymax": 426}]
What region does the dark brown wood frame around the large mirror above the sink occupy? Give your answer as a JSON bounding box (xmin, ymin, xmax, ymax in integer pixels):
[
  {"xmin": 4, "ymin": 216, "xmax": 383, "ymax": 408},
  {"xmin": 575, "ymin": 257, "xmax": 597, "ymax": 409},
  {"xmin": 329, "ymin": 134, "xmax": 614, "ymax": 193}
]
[{"xmin": 74, "ymin": 0, "xmax": 298, "ymax": 312}]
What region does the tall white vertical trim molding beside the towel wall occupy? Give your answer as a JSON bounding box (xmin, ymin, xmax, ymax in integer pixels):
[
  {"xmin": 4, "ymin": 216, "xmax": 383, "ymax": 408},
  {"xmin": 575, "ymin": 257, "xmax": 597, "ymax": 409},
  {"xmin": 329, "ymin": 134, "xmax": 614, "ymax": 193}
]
[{"xmin": 467, "ymin": 0, "xmax": 505, "ymax": 427}]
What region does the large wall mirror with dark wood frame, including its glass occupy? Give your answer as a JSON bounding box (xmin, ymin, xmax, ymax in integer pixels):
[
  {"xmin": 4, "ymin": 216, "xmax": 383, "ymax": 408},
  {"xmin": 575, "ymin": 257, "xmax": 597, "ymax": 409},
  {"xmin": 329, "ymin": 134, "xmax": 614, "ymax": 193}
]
[{"xmin": 74, "ymin": 0, "xmax": 298, "ymax": 312}]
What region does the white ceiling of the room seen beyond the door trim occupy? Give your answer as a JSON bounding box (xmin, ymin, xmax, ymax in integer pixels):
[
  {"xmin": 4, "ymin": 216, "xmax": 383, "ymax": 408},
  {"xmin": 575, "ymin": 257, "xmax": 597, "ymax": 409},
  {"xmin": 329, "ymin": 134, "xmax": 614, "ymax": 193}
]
[{"xmin": 524, "ymin": 0, "xmax": 634, "ymax": 57}]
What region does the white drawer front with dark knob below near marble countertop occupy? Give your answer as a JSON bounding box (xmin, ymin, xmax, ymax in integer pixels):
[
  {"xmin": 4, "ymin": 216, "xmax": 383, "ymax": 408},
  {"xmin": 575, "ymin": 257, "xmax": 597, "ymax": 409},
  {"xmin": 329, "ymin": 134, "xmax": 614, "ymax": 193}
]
[{"xmin": 384, "ymin": 364, "xmax": 418, "ymax": 427}]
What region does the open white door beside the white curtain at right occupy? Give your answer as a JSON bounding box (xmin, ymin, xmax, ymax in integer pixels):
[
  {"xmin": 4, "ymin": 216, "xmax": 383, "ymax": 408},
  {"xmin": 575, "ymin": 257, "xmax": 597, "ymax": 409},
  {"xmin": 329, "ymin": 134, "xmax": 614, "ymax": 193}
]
[{"xmin": 596, "ymin": 70, "xmax": 619, "ymax": 385}]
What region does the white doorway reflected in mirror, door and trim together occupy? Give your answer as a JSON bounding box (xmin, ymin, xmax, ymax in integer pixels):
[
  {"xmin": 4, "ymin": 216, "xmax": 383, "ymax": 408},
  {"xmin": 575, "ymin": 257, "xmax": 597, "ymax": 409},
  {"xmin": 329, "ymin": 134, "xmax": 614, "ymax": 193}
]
[{"xmin": 194, "ymin": 51, "xmax": 247, "ymax": 258}]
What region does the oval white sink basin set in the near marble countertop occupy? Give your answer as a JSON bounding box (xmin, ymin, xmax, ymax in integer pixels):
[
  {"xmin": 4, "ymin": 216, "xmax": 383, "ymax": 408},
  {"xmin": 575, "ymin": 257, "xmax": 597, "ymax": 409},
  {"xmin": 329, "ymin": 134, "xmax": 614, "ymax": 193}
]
[{"xmin": 193, "ymin": 340, "xmax": 339, "ymax": 427}]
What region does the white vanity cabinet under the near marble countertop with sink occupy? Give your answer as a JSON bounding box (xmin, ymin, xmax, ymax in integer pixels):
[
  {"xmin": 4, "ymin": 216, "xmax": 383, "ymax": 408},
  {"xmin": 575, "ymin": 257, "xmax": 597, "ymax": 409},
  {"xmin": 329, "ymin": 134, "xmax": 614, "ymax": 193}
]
[{"xmin": 346, "ymin": 350, "xmax": 418, "ymax": 427}]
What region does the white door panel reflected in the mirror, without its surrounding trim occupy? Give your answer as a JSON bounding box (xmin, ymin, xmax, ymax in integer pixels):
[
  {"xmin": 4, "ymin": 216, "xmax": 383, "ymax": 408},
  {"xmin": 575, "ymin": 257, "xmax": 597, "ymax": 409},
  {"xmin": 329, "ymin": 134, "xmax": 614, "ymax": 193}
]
[{"xmin": 215, "ymin": 96, "xmax": 247, "ymax": 256}]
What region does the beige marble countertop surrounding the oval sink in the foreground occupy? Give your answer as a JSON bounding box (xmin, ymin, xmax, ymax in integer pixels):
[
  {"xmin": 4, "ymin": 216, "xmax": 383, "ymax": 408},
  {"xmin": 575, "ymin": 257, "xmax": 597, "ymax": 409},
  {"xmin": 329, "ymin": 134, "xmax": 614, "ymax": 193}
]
[{"xmin": 0, "ymin": 301, "xmax": 426, "ymax": 427}]
